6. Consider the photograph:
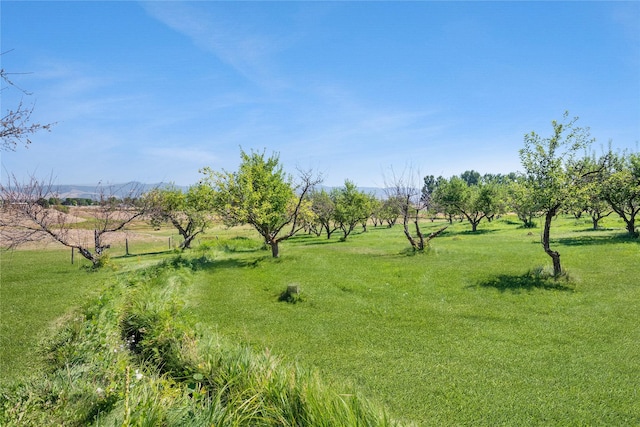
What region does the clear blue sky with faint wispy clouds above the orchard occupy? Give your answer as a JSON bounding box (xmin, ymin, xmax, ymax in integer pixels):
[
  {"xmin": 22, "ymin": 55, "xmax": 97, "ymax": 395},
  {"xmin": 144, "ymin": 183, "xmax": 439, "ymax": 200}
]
[{"xmin": 0, "ymin": 0, "xmax": 640, "ymax": 186}]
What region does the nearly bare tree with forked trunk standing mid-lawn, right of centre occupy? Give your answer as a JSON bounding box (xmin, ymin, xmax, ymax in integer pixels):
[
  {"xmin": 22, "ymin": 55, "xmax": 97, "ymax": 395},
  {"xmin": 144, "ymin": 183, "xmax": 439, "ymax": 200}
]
[{"xmin": 385, "ymin": 168, "xmax": 448, "ymax": 251}]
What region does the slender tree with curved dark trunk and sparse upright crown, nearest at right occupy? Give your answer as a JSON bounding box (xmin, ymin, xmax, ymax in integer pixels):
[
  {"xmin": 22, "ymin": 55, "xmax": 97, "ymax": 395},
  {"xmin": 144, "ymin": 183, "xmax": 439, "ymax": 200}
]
[{"xmin": 520, "ymin": 113, "xmax": 592, "ymax": 277}]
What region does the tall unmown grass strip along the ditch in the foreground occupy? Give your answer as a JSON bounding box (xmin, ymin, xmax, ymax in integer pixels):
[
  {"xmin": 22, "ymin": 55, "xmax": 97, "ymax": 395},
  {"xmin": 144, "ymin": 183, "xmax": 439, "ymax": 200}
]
[{"xmin": 0, "ymin": 257, "xmax": 394, "ymax": 426}]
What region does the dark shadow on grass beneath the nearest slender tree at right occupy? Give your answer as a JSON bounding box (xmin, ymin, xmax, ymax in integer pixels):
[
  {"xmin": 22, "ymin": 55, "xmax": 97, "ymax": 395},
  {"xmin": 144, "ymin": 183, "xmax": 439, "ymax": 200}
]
[{"xmin": 472, "ymin": 269, "xmax": 575, "ymax": 293}]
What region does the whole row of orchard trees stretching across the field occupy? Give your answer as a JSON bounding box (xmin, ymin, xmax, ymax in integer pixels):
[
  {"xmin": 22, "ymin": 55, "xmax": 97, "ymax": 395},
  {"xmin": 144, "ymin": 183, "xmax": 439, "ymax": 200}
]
[{"xmin": 0, "ymin": 114, "xmax": 640, "ymax": 275}]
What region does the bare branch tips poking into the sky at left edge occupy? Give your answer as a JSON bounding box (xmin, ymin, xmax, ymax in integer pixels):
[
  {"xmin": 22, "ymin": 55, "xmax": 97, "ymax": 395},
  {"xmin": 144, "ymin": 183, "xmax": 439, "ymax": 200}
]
[{"xmin": 0, "ymin": 52, "xmax": 55, "ymax": 151}]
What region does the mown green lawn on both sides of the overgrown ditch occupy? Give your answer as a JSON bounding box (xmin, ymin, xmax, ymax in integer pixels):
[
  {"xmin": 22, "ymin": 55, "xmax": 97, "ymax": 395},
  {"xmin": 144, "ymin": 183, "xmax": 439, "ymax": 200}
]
[{"xmin": 0, "ymin": 218, "xmax": 640, "ymax": 425}]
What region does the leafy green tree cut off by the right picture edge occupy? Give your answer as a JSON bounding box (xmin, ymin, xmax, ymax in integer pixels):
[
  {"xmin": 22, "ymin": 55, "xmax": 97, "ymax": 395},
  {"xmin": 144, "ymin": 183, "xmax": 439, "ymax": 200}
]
[{"xmin": 602, "ymin": 151, "xmax": 640, "ymax": 237}]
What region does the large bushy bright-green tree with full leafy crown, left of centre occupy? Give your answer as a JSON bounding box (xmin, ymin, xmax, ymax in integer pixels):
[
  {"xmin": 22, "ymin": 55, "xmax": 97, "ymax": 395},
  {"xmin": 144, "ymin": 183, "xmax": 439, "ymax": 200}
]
[{"xmin": 202, "ymin": 150, "xmax": 322, "ymax": 258}]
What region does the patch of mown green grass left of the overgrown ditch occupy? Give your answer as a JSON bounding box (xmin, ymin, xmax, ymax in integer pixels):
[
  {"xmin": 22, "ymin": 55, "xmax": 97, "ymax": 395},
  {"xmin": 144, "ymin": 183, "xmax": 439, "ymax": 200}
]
[{"xmin": 0, "ymin": 250, "xmax": 111, "ymax": 383}]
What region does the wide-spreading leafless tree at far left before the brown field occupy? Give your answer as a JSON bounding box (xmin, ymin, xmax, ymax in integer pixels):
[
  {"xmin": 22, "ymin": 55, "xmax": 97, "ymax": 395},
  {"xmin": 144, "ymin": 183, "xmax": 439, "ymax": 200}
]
[{"xmin": 0, "ymin": 175, "xmax": 145, "ymax": 267}]
